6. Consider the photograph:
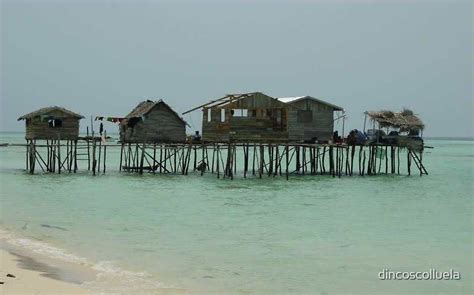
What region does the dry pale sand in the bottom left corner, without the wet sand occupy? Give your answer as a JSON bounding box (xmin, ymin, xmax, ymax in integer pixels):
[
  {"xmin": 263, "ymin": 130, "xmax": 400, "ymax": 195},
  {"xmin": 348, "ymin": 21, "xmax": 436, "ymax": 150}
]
[{"xmin": 0, "ymin": 249, "xmax": 91, "ymax": 294}]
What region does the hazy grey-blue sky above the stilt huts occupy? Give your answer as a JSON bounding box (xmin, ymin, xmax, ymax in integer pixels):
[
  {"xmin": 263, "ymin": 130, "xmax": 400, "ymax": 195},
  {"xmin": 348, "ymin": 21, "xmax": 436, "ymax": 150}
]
[{"xmin": 0, "ymin": 0, "xmax": 474, "ymax": 137}]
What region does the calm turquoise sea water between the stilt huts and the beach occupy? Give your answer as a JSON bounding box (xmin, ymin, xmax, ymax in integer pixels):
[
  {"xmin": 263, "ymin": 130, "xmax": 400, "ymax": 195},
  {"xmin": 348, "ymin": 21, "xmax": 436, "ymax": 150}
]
[{"xmin": 0, "ymin": 133, "xmax": 474, "ymax": 294}]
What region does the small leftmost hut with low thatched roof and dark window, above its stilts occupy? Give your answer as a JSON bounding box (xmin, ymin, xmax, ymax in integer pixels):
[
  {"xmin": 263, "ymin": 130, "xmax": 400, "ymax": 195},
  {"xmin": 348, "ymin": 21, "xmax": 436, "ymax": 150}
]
[{"xmin": 18, "ymin": 106, "xmax": 84, "ymax": 140}]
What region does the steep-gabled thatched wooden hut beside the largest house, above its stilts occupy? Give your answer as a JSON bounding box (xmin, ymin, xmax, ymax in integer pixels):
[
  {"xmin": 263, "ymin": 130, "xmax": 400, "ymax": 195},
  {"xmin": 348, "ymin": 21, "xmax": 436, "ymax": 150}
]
[{"xmin": 120, "ymin": 100, "xmax": 187, "ymax": 143}]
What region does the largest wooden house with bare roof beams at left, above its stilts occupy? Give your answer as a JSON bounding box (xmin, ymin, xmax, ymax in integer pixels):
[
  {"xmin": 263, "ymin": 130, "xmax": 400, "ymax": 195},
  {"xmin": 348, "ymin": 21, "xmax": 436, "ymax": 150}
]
[{"xmin": 183, "ymin": 92, "xmax": 343, "ymax": 142}]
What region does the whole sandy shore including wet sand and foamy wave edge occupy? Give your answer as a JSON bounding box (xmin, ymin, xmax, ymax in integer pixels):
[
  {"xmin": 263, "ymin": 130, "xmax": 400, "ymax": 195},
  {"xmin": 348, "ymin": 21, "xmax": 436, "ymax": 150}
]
[{"xmin": 0, "ymin": 228, "xmax": 188, "ymax": 295}]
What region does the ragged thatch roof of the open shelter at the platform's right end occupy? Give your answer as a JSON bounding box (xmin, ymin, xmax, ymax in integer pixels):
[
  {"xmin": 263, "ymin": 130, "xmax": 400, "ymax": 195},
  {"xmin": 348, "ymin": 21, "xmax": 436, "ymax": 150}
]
[{"xmin": 366, "ymin": 109, "xmax": 425, "ymax": 131}]
